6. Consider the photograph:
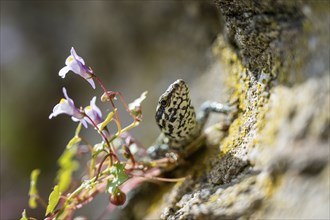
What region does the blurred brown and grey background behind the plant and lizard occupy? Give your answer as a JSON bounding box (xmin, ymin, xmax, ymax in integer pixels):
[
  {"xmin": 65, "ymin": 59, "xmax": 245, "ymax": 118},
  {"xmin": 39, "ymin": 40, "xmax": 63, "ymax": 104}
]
[{"xmin": 0, "ymin": 1, "xmax": 222, "ymax": 219}]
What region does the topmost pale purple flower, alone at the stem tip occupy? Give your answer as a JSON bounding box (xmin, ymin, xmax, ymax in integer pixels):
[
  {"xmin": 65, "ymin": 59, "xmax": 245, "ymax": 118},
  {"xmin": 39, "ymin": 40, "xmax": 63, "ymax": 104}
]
[{"xmin": 58, "ymin": 47, "xmax": 95, "ymax": 89}]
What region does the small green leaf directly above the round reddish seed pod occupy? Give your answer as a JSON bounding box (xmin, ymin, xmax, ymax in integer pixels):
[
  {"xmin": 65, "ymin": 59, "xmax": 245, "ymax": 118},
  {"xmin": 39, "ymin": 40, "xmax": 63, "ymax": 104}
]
[{"xmin": 107, "ymin": 163, "xmax": 128, "ymax": 194}]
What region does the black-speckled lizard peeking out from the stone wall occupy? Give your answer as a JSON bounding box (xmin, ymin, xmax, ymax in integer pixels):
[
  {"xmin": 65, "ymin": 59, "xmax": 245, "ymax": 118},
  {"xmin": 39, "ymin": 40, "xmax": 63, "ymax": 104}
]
[{"xmin": 147, "ymin": 79, "xmax": 235, "ymax": 169}]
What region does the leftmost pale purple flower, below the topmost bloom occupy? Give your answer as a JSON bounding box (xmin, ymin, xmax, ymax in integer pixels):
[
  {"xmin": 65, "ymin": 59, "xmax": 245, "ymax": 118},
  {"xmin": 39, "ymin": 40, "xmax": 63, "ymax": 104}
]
[{"xmin": 49, "ymin": 87, "xmax": 87, "ymax": 128}]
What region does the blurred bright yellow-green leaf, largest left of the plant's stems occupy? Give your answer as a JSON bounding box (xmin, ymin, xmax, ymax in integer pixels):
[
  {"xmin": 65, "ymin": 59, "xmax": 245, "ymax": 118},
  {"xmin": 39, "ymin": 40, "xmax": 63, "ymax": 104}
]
[{"xmin": 56, "ymin": 147, "xmax": 79, "ymax": 192}]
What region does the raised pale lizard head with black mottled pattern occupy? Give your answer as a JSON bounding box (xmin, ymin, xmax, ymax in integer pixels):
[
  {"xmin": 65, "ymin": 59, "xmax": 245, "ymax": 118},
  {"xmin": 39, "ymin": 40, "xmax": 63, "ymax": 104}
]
[{"xmin": 156, "ymin": 79, "xmax": 197, "ymax": 146}]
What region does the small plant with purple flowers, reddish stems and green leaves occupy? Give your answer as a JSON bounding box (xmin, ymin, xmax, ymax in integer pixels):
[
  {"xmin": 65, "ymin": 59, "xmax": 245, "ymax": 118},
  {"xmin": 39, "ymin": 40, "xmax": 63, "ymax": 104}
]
[{"xmin": 21, "ymin": 48, "xmax": 177, "ymax": 220}]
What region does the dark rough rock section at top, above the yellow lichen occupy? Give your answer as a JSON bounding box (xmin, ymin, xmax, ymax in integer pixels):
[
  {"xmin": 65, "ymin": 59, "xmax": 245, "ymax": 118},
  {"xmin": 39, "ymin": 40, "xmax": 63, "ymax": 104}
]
[{"xmin": 217, "ymin": 0, "xmax": 303, "ymax": 78}]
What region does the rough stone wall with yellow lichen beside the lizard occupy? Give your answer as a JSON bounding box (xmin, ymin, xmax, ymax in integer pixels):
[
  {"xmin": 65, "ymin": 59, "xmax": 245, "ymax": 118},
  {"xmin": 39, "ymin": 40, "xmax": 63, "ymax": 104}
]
[{"xmin": 115, "ymin": 0, "xmax": 330, "ymax": 219}]
